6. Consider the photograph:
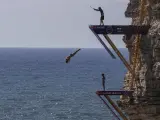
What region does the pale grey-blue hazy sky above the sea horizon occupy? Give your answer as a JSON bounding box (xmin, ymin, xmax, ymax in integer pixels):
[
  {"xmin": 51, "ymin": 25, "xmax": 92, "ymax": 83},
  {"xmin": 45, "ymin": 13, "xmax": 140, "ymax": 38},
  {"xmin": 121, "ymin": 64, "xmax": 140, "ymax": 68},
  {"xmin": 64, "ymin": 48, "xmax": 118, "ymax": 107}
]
[{"xmin": 0, "ymin": 0, "xmax": 131, "ymax": 48}]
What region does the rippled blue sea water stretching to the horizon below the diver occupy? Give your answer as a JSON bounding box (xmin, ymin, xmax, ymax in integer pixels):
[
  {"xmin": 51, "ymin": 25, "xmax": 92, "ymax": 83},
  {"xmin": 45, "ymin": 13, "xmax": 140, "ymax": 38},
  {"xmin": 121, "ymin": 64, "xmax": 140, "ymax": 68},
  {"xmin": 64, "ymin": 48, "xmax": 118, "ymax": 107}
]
[{"xmin": 0, "ymin": 48, "xmax": 128, "ymax": 120}]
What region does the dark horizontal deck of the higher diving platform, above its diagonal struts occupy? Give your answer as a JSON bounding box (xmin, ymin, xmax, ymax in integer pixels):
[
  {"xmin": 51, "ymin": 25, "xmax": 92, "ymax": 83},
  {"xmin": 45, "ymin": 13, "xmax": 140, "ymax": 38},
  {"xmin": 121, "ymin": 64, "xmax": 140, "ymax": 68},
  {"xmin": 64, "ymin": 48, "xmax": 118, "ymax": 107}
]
[{"xmin": 89, "ymin": 25, "xmax": 150, "ymax": 35}]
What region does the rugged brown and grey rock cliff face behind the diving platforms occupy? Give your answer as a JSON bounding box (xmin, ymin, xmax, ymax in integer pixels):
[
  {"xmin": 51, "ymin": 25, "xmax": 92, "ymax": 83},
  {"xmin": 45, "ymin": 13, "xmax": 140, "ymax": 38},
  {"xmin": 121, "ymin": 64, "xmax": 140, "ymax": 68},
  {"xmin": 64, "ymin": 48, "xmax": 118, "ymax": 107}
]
[{"xmin": 121, "ymin": 0, "xmax": 160, "ymax": 120}]
